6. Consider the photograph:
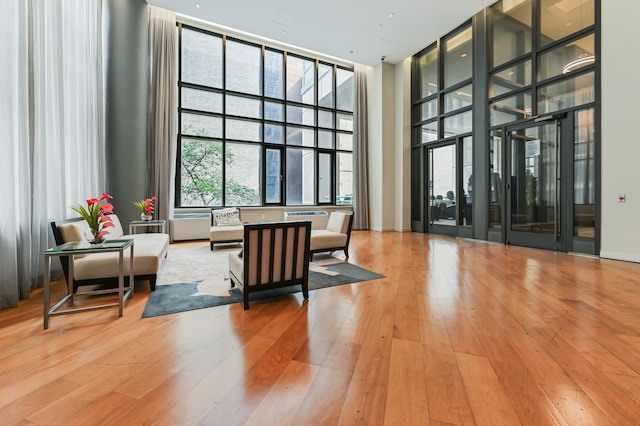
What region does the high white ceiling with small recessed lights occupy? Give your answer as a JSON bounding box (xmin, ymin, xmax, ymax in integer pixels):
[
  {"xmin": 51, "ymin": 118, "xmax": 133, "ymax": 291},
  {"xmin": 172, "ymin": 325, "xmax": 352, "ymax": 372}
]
[{"xmin": 147, "ymin": 0, "xmax": 496, "ymax": 66}]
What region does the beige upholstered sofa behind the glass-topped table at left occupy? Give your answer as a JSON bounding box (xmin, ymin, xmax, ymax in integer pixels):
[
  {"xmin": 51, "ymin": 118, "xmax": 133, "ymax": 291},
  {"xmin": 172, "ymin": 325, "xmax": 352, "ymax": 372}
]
[{"xmin": 51, "ymin": 215, "xmax": 169, "ymax": 291}]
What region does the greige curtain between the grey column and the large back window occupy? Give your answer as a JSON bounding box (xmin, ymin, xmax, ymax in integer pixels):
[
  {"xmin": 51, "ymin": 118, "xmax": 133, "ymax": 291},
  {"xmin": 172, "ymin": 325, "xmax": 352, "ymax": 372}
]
[{"xmin": 147, "ymin": 6, "xmax": 178, "ymax": 234}]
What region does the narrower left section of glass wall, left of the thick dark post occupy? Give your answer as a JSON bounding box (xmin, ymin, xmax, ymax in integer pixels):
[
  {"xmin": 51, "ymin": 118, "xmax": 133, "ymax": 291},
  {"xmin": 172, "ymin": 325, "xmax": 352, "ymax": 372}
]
[{"xmin": 412, "ymin": 23, "xmax": 474, "ymax": 234}]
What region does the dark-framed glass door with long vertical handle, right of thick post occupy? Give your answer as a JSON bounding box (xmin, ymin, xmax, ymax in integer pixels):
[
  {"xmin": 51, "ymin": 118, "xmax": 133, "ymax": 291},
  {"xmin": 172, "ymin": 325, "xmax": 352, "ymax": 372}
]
[{"xmin": 506, "ymin": 120, "xmax": 566, "ymax": 251}]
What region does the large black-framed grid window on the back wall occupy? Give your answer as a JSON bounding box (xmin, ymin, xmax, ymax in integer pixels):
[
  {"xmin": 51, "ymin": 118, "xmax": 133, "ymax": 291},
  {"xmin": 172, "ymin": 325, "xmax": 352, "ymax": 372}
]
[{"xmin": 176, "ymin": 24, "xmax": 354, "ymax": 207}]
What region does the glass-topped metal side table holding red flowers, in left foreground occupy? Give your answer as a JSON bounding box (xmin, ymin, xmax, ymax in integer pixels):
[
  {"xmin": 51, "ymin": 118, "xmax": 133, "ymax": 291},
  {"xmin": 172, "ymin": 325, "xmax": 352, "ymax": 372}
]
[{"xmin": 44, "ymin": 239, "xmax": 134, "ymax": 330}]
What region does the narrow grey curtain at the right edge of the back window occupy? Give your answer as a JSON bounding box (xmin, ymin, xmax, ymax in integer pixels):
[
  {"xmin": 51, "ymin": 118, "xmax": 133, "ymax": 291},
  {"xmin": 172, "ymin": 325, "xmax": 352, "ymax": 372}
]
[{"xmin": 353, "ymin": 64, "xmax": 369, "ymax": 229}]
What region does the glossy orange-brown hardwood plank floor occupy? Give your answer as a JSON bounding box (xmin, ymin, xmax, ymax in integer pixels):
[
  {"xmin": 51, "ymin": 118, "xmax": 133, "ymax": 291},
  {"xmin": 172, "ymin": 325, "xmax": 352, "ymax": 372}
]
[{"xmin": 0, "ymin": 232, "xmax": 640, "ymax": 425}]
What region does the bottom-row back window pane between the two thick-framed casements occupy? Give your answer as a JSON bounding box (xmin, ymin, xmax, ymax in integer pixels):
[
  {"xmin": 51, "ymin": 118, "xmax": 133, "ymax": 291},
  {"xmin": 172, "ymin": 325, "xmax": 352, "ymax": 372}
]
[{"xmin": 286, "ymin": 148, "xmax": 316, "ymax": 205}]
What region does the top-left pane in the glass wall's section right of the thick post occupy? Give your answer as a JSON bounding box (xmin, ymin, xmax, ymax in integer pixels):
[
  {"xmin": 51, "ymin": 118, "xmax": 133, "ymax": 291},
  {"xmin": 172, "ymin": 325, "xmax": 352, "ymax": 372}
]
[{"xmin": 491, "ymin": 0, "xmax": 532, "ymax": 67}]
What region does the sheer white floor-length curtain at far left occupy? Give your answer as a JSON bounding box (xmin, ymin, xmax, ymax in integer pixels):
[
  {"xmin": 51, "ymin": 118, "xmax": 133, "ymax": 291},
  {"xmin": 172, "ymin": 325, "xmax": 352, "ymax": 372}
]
[{"xmin": 0, "ymin": 0, "xmax": 105, "ymax": 309}]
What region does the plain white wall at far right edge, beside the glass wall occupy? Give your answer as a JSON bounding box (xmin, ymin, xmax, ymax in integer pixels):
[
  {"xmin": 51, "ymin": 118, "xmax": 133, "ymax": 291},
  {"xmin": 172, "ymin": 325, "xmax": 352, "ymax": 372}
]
[{"xmin": 600, "ymin": 0, "xmax": 640, "ymax": 262}]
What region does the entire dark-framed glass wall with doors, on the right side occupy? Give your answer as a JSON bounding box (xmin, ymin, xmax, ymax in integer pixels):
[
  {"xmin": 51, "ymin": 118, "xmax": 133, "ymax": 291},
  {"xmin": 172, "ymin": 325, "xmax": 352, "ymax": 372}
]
[{"xmin": 412, "ymin": 0, "xmax": 599, "ymax": 253}]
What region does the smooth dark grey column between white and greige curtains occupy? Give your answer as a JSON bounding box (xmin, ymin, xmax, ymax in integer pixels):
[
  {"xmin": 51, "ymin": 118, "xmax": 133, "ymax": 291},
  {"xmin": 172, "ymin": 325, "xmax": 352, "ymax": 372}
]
[{"xmin": 103, "ymin": 0, "xmax": 153, "ymax": 229}]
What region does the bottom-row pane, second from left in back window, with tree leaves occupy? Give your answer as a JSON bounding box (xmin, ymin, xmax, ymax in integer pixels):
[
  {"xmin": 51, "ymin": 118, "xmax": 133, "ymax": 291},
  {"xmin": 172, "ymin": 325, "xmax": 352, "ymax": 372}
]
[{"xmin": 224, "ymin": 143, "xmax": 262, "ymax": 206}]
